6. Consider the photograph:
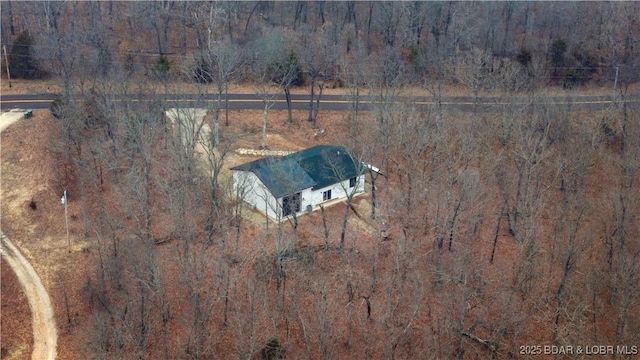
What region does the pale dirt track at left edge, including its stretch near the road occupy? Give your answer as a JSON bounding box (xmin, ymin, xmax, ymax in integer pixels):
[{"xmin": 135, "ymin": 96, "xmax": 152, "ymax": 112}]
[{"xmin": 0, "ymin": 113, "xmax": 58, "ymax": 360}]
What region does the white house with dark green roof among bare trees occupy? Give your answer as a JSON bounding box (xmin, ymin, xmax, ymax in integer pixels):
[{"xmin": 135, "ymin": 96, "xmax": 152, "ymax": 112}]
[{"xmin": 231, "ymin": 145, "xmax": 367, "ymax": 221}]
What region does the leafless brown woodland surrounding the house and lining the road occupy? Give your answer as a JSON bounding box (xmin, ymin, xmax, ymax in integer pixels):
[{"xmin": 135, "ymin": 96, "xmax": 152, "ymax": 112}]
[{"xmin": 0, "ymin": 1, "xmax": 640, "ymax": 359}]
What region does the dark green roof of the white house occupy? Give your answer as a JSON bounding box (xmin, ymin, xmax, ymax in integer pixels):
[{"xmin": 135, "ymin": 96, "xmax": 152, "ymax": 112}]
[{"xmin": 231, "ymin": 145, "xmax": 363, "ymax": 198}]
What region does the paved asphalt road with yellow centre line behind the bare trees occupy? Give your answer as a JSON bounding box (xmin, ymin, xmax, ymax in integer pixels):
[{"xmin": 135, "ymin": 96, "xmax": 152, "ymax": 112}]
[{"xmin": 0, "ymin": 90, "xmax": 638, "ymax": 111}]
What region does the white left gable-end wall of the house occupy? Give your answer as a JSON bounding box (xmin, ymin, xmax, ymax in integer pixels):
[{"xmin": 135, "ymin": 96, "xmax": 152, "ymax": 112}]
[{"xmin": 231, "ymin": 170, "xmax": 282, "ymax": 220}]
